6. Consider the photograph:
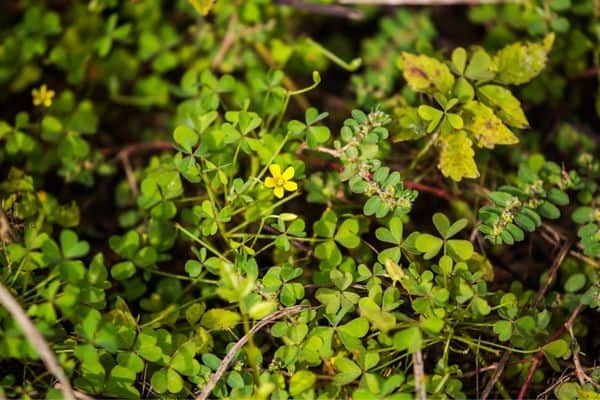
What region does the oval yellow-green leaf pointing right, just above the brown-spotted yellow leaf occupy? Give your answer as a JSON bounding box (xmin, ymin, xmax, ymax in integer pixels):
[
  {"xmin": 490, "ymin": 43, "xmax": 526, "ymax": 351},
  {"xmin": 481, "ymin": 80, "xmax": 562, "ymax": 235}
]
[{"xmin": 477, "ymin": 85, "xmax": 529, "ymax": 129}]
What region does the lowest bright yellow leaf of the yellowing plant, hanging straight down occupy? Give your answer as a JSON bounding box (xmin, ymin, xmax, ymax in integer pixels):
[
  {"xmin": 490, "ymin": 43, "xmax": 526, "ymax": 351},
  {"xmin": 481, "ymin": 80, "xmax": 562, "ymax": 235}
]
[{"xmin": 438, "ymin": 131, "xmax": 479, "ymax": 181}]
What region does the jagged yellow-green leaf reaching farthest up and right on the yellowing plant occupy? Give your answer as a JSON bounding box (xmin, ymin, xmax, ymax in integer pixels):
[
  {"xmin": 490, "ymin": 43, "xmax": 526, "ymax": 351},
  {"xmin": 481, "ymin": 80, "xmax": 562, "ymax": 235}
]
[{"xmin": 494, "ymin": 33, "xmax": 554, "ymax": 85}]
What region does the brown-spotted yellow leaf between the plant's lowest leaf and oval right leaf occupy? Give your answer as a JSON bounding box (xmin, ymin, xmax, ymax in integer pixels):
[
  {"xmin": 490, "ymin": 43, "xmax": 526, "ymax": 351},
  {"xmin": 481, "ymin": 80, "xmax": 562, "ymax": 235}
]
[{"xmin": 463, "ymin": 100, "xmax": 519, "ymax": 149}]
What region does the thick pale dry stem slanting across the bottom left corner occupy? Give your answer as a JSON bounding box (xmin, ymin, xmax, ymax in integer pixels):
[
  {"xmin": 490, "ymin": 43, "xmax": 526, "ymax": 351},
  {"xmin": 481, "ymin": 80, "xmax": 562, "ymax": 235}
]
[{"xmin": 0, "ymin": 283, "xmax": 75, "ymax": 400}]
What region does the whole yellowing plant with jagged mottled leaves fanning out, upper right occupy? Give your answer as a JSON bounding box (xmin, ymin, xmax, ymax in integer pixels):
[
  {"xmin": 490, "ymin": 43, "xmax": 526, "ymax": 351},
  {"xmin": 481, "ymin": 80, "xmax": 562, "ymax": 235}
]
[{"xmin": 395, "ymin": 35, "xmax": 554, "ymax": 181}]
